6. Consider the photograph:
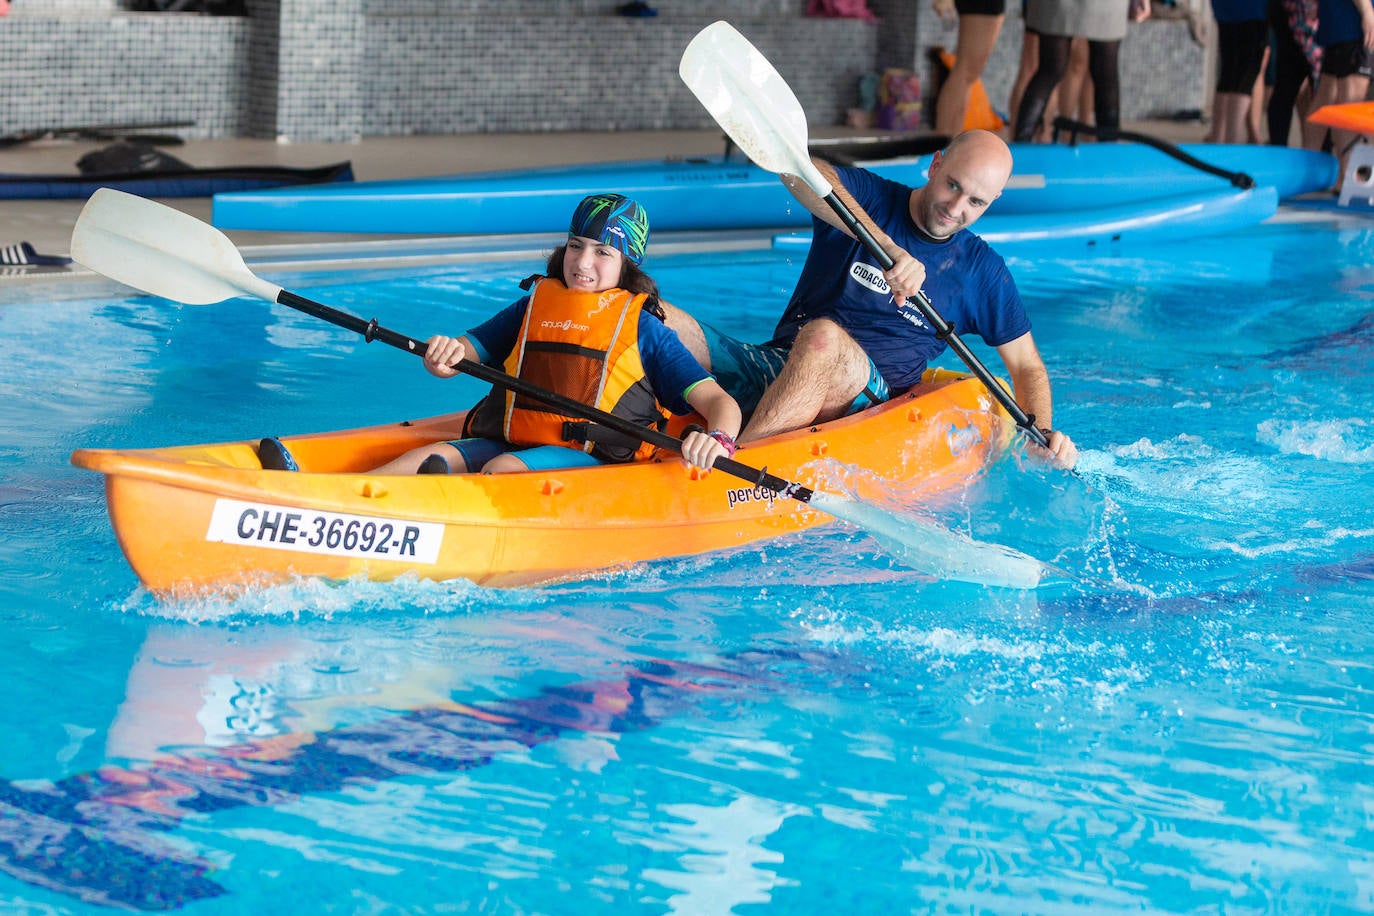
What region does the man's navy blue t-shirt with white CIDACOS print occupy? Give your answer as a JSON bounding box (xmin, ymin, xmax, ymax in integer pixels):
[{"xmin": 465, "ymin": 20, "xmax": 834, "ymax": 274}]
[{"xmin": 769, "ymin": 168, "xmax": 1031, "ymax": 391}]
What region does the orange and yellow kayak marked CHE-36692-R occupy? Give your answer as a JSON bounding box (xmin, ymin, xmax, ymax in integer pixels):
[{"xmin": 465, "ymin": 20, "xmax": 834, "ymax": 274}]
[{"xmin": 71, "ymin": 369, "xmax": 1014, "ymax": 596}]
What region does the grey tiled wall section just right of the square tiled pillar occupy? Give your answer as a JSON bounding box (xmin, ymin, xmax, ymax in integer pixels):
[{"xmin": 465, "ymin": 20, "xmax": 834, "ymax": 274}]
[{"xmin": 361, "ymin": 14, "xmax": 877, "ymax": 135}]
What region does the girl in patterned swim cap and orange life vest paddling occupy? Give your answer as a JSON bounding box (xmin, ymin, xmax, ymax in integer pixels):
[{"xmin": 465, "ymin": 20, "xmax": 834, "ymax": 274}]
[{"xmin": 258, "ymin": 194, "xmax": 741, "ymax": 474}]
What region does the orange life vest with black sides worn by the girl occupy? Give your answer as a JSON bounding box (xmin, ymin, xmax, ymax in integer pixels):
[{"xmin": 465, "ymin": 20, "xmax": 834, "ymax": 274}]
[{"xmin": 463, "ymin": 277, "xmax": 668, "ymax": 461}]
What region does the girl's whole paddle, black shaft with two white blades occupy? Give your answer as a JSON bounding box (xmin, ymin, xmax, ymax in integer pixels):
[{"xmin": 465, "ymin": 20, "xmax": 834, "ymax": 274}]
[{"xmin": 71, "ymin": 188, "xmax": 1044, "ymax": 588}]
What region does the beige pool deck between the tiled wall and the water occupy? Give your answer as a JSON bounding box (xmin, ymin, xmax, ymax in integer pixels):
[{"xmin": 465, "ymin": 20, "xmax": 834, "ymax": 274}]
[{"xmin": 0, "ymin": 121, "xmax": 1206, "ymax": 283}]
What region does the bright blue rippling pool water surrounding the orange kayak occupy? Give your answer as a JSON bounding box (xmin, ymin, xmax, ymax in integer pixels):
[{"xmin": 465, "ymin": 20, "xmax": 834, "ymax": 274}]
[{"xmin": 0, "ymin": 211, "xmax": 1374, "ymax": 913}]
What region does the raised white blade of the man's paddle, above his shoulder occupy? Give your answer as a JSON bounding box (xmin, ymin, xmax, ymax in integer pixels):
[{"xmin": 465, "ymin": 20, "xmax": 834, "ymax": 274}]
[{"xmin": 677, "ymin": 21, "xmax": 830, "ymax": 198}]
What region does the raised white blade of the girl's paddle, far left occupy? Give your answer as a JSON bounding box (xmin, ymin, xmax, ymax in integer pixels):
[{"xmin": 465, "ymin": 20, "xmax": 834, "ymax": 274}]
[{"xmin": 71, "ymin": 188, "xmax": 282, "ymax": 305}]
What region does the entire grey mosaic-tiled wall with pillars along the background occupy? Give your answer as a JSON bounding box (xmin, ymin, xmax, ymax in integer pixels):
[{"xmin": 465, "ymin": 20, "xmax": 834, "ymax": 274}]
[{"xmin": 0, "ymin": 0, "xmax": 1205, "ymax": 143}]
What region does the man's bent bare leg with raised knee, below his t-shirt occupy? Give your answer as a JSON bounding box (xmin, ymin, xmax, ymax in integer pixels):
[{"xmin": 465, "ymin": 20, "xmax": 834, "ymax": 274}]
[{"xmin": 739, "ymin": 319, "xmax": 868, "ymax": 442}]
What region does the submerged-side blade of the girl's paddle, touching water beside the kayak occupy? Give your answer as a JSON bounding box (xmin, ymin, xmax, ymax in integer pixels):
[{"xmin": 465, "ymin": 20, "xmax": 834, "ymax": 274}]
[{"xmin": 811, "ymin": 493, "xmax": 1047, "ymax": 588}]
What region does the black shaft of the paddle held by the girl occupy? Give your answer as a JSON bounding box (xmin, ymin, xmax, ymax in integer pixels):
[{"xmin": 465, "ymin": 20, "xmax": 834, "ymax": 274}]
[{"xmin": 276, "ymin": 290, "xmax": 812, "ymax": 503}]
